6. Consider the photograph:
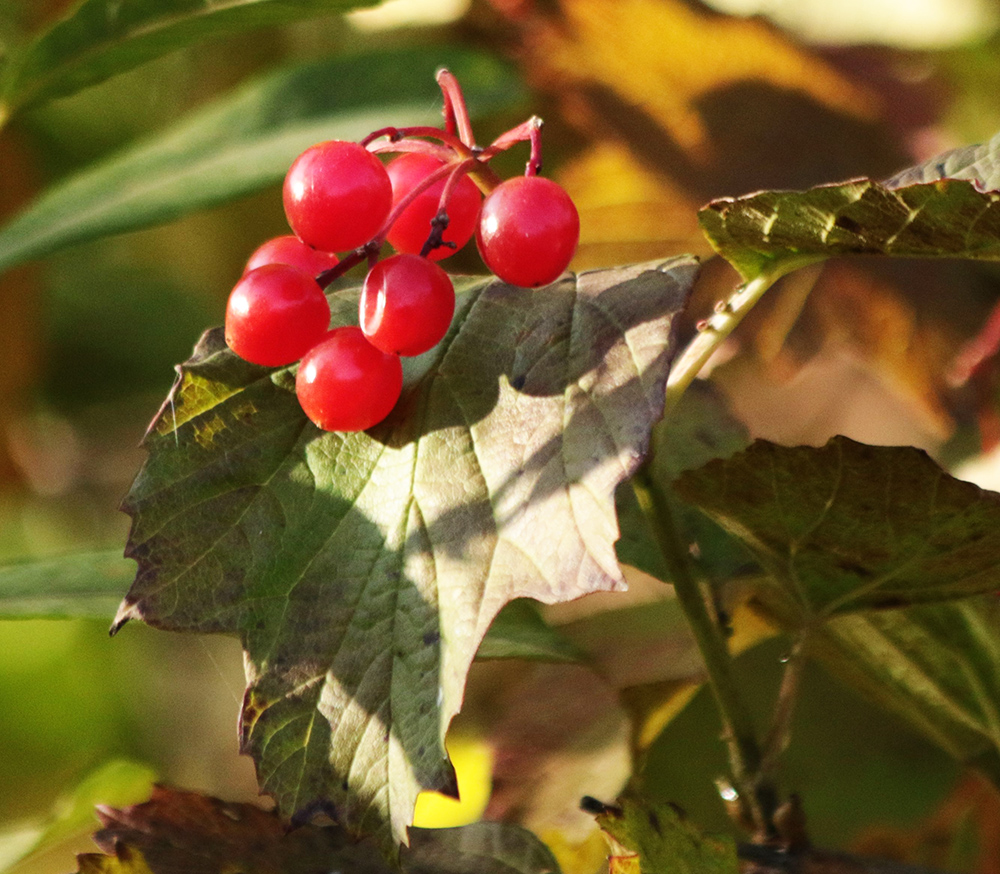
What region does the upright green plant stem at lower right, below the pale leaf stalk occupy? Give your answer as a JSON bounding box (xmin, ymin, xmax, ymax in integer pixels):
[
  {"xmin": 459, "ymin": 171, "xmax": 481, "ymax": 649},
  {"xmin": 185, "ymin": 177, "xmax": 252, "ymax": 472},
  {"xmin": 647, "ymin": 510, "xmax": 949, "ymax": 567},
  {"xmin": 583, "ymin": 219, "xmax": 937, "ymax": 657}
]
[{"xmin": 632, "ymin": 468, "xmax": 777, "ymax": 838}]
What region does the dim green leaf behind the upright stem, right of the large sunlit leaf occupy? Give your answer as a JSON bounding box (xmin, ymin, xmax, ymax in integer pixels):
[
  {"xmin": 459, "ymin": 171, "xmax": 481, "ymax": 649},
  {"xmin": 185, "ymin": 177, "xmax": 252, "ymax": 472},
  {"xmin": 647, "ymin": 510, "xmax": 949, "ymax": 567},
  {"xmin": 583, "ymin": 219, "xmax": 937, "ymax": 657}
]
[{"xmin": 617, "ymin": 381, "xmax": 750, "ymax": 582}]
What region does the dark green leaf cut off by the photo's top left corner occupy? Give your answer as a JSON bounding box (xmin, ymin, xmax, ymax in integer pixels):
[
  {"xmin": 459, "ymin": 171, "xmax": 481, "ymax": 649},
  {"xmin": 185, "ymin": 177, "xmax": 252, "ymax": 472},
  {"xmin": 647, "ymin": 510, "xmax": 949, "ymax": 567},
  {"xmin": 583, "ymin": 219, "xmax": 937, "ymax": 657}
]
[{"xmin": 0, "ymin": 0, "xmax": 376, "ymax": 118}]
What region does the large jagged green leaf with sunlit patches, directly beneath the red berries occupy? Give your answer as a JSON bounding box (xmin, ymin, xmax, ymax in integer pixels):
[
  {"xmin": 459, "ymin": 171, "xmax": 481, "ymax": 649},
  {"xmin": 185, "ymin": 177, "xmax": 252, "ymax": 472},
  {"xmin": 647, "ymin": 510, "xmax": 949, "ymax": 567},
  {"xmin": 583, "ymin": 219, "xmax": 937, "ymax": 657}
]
[{"xmin": 118, "ymin": 258, "xmax": 697, "ymax": 849}]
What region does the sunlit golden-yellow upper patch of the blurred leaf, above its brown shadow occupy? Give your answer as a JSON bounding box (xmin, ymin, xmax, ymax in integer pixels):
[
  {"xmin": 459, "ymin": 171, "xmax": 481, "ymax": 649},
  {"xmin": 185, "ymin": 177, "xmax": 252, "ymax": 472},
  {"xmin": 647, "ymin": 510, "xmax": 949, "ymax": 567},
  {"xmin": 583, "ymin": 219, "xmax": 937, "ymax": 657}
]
[{"xmin": 528, "ymin": 0, "xmax": 878, "ymax": 154}]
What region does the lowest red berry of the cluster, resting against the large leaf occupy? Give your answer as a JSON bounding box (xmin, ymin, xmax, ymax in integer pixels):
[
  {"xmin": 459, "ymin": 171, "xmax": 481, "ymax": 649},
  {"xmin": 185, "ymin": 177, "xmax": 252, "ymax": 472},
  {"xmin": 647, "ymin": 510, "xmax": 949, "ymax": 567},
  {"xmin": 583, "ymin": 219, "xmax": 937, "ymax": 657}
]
[{"xmin": 295, "ymin": 325, "xmax": 403, "ymax": 431}]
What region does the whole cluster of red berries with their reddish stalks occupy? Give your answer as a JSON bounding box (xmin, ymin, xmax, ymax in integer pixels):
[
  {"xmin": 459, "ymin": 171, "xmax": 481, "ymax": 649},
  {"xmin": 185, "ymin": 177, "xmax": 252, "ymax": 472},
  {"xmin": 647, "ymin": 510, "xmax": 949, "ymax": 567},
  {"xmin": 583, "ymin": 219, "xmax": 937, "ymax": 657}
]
[{"xmin": 219, "ymin": 70, "xmax": 580, "ymax": 431}]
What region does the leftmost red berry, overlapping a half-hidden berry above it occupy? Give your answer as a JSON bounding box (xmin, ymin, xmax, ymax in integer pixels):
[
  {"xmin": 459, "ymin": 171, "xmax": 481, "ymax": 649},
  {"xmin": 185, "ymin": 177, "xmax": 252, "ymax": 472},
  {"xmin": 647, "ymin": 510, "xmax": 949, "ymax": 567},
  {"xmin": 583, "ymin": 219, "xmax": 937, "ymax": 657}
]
[{"xmin": 226, "ymin": 264, "xmax": 330, "ymax": 367}]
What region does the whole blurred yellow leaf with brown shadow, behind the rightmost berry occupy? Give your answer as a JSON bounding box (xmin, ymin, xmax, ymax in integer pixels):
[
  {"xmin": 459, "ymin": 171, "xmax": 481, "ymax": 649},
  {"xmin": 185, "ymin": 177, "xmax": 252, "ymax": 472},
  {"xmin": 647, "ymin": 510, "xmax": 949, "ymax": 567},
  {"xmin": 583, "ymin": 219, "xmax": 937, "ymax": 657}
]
[{"xmin": 493, "ymin": 0, "xmax": 903, "ymax": 267}]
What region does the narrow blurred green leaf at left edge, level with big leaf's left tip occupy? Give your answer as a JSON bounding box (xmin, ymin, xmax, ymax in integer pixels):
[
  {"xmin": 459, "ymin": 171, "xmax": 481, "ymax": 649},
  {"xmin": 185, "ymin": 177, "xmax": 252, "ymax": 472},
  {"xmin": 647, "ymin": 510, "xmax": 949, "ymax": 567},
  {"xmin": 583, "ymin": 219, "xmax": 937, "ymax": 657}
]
[{"xmin": 0, "ymin": 549, "xmax": 135, "ymax": 619}]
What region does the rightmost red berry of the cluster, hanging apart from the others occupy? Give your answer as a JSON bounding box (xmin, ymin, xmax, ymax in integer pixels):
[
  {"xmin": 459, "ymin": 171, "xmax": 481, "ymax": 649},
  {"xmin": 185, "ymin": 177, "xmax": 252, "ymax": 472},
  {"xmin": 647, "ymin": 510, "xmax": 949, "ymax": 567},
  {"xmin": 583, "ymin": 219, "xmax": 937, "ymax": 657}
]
[{"xmin": 476, "ymin": 176, "xmax": 580, "ymax": 288}]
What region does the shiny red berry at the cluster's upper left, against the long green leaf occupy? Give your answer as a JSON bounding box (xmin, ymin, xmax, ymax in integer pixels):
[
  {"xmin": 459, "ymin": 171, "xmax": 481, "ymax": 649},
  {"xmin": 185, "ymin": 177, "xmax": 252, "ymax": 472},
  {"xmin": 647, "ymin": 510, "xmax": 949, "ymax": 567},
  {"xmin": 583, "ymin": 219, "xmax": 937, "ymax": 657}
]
[{"xmin": 283, "ymin": 140, "xmax": 392, "ymax": 252}]
